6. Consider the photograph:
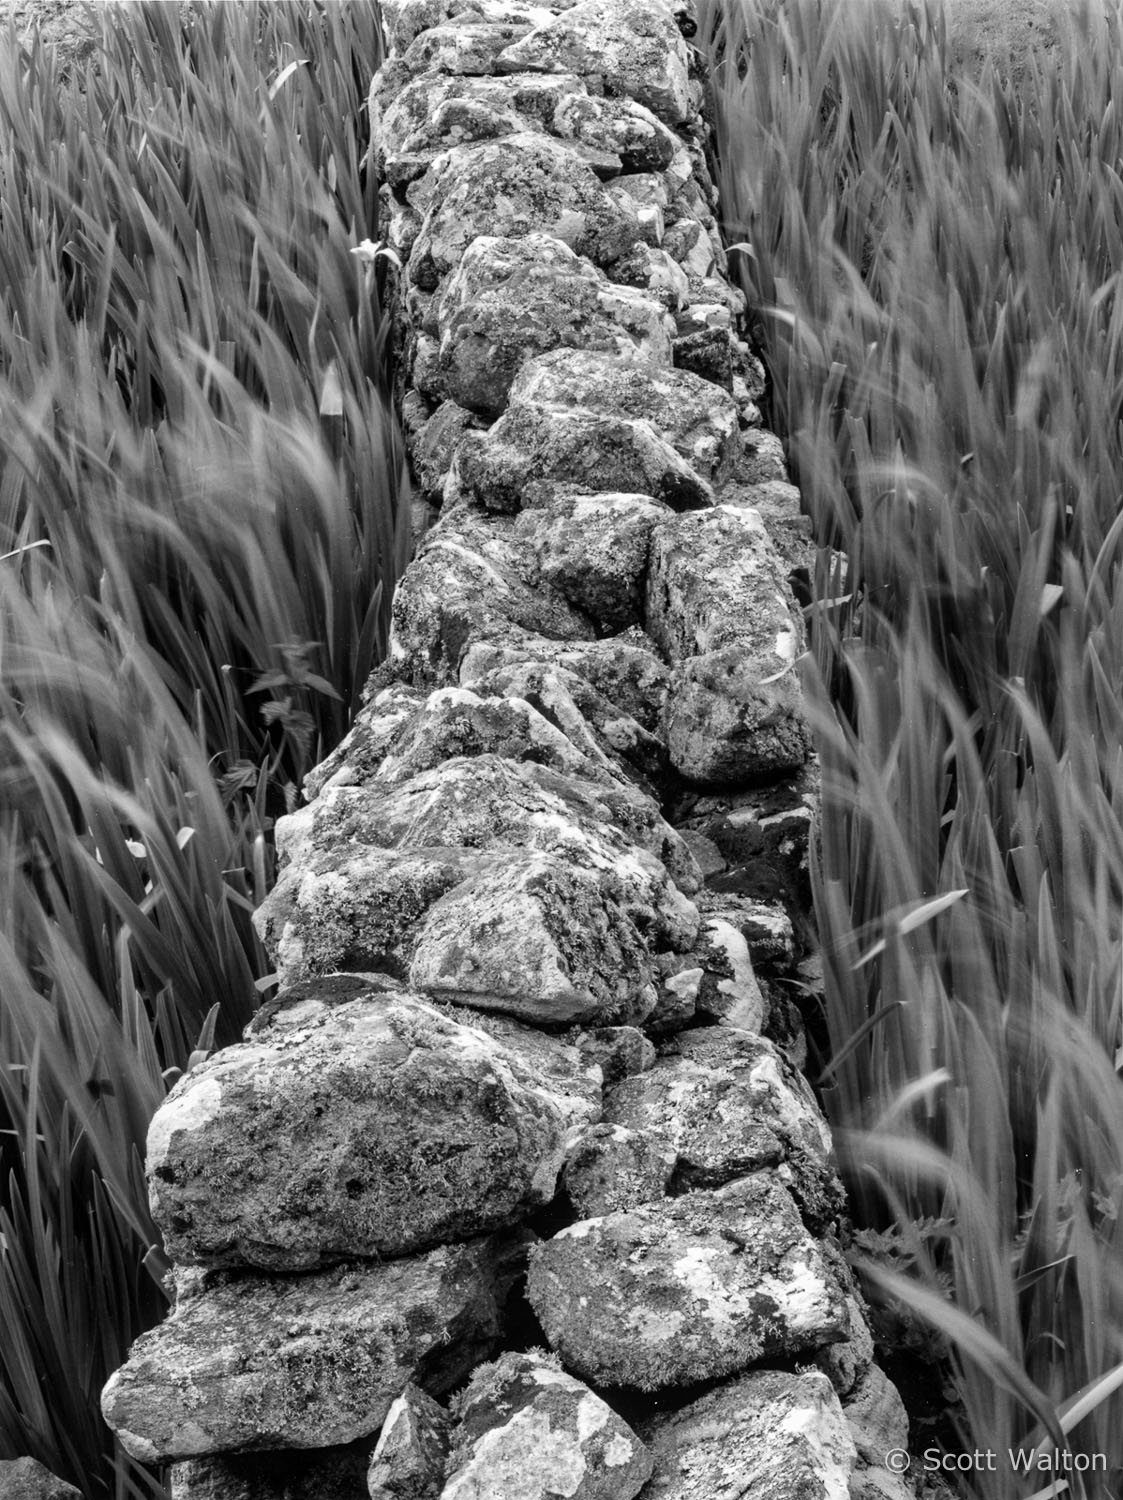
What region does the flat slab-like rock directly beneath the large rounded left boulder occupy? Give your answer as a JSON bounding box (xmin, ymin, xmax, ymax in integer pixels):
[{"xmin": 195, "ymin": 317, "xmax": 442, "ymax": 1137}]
[{"xmin": 102, "ymin": 1242, "xmax": 498, "ymax": 1464}]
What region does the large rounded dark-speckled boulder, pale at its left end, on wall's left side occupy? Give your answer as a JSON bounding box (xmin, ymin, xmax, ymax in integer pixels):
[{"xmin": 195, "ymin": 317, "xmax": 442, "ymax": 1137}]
[{"xmin": 148, "ymin": 987, "xmax": 572, "ymax": 1272}]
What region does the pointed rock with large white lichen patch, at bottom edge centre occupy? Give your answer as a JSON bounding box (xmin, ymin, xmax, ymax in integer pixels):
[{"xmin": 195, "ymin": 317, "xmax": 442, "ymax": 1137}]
[{"xmin": 441, "ymin": 1350, "xmax": 651, "ymax": 1500}]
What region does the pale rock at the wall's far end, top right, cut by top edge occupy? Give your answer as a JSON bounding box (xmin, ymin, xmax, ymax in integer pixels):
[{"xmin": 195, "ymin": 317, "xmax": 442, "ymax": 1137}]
[{"xmin": 496, "ymin": 0, "xmax": 691, "ymax": 125}]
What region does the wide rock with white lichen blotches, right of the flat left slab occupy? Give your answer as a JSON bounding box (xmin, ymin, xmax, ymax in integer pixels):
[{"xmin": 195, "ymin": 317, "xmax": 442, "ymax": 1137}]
[{"xmin": 526, "ymin": 1173, "xmax": 846, "ymax": 1391}]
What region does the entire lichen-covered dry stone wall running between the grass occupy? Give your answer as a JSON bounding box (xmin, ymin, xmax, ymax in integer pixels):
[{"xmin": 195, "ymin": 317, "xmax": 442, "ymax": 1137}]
[{"xmin": 103, "ymin": 0, "xmax": 906, "ymax": 1500}]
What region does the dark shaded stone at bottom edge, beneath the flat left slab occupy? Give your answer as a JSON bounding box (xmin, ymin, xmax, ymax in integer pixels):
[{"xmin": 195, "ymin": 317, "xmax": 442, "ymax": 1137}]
[{"xmin": 168, "ymin": 1437, "xmax": 370, "ymax": 1500}]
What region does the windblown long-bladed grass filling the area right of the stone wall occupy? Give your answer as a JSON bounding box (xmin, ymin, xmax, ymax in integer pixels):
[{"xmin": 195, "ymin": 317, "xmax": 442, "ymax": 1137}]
[{"xmin": 700, "ymin": 0, "xmax": 1123, "ymax": 1500}]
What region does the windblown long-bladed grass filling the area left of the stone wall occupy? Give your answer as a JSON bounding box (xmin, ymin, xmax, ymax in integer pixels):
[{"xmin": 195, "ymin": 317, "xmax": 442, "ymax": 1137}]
[{"xmin": 0, "ymin": 0, "xmax": 409, "ymax": 1500}]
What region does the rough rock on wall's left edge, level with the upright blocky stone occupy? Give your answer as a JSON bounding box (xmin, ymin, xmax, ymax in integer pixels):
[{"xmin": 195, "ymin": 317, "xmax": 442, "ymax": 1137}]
[{"xmin": 390, "ymin": 513, "xmax": 594, "ymax": 681}]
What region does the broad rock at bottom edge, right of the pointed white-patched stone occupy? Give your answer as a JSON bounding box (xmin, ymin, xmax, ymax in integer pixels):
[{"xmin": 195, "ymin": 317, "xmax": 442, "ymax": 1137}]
[{"xmin": 642, "ymin": 1370, "xmax": 855, "ymax": 1500}]
